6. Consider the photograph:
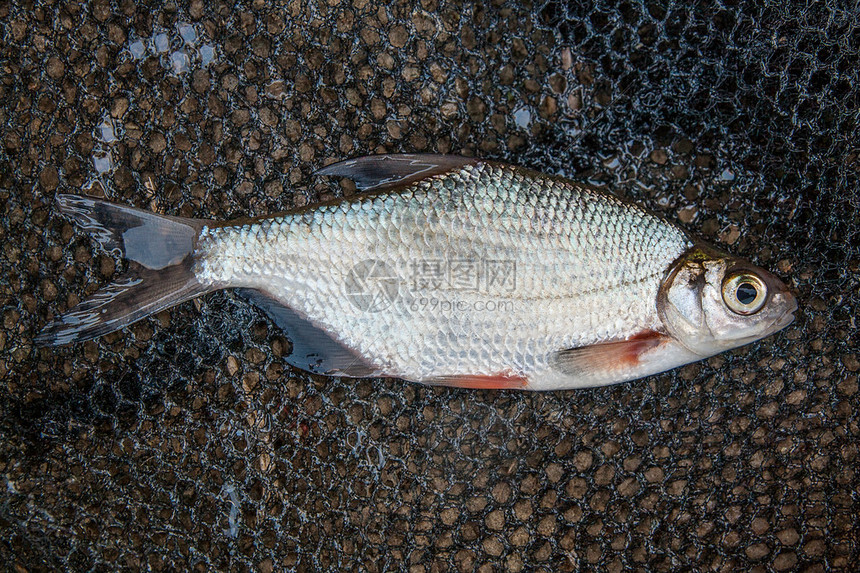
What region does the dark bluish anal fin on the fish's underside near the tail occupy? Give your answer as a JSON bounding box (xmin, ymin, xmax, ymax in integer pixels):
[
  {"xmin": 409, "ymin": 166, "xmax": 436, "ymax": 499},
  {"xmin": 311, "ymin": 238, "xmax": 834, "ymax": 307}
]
[{"xmin": 236, "ymin": 288, "xmax": 381, "ymax": 378}]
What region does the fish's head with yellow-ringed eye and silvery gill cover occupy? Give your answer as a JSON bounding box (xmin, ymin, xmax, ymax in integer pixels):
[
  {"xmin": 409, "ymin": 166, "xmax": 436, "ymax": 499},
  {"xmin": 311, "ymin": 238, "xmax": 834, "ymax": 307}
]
[{"xmin": 657, "ymin": 245, "xmax": 797, "ymax": 357}]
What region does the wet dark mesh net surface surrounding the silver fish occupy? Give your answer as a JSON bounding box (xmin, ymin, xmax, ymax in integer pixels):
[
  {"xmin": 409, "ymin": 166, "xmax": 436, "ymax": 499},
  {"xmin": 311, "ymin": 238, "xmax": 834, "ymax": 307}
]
[{"xmin": 0, "ymin": 0, "xmax": 860, "ymax": 573}]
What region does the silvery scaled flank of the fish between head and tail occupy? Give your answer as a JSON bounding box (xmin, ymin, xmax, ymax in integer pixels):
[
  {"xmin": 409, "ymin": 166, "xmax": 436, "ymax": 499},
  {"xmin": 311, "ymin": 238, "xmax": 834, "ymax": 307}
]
[{"xmin": 197, "ymin": 163, "xmax": 692, "ymax": 380}]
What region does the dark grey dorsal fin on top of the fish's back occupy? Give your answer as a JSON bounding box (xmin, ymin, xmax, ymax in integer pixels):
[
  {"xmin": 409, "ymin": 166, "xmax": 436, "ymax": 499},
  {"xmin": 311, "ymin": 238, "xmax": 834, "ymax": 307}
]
[{"xmin": 316, "ymin": 153, "xmax": 480, "ymax": 191}]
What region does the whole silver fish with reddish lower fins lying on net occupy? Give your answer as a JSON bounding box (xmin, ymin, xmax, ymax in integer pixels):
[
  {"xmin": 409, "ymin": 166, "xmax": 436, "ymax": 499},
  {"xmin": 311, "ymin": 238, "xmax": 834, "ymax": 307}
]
[{"xmin": 35, "ymin": 154, "xmax": 797, "ymax": 391}]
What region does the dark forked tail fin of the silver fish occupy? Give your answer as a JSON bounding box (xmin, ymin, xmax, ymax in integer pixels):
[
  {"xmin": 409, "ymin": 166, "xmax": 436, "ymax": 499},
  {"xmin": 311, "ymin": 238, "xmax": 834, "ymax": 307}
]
[{"xmin": 34, "ymin": 194, "xmax": 217, "ymax": 346}]
